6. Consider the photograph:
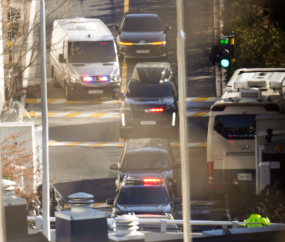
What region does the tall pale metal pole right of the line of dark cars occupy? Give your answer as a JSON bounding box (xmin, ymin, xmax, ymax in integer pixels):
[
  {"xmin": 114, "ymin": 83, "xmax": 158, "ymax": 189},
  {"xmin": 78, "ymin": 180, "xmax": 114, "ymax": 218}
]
[{"xmin": 176, "ymin": 0, "xmax": 192, "ymax": 242}]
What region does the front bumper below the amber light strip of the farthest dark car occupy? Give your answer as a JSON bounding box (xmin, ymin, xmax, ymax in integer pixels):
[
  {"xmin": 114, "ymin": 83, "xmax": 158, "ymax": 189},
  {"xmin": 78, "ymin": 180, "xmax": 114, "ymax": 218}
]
[{"xmin": 119, "ymin": 45, "xmax": 167, "ymax": 58}]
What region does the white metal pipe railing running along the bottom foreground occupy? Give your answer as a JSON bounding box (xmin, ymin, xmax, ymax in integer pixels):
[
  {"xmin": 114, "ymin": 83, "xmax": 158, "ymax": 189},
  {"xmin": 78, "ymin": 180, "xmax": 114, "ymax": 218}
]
[{"xmin": 27, "ymin": 216, "xmax": 245, "ymax": 233}]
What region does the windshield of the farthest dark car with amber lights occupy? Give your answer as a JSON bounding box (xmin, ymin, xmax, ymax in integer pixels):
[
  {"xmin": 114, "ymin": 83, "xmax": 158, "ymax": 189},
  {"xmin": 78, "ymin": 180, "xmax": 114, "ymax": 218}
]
[{"xmin": 122, "ymin": 15, "xmax": 163, "ymax": 32}]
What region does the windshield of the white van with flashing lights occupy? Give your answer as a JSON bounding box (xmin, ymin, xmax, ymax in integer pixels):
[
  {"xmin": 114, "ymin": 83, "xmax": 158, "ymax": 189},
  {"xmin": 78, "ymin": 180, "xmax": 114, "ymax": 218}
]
[{"xmin": 68, "ymin": 41, "xmax": 116, "ymax": 63}]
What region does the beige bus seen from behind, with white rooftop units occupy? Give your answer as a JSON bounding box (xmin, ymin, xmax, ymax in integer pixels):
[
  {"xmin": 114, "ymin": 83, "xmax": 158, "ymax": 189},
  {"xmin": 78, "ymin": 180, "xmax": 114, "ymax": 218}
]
[{"xmin": 207, "ymin": 68, "xmax": 285, "ymax": 194}]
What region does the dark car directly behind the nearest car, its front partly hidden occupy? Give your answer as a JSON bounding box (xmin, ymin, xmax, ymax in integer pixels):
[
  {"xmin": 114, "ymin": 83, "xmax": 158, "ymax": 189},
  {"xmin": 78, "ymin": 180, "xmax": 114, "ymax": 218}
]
[{"xmin": 110, "ymin": 138, "xmax": 181, "ymax": 197}]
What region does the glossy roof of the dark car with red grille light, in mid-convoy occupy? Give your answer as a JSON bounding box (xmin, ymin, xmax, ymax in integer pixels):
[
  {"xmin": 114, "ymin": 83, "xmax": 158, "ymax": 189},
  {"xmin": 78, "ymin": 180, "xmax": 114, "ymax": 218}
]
[{"xmin": 132, "ymin": 62, "xmax": 170, "ymax": 83}]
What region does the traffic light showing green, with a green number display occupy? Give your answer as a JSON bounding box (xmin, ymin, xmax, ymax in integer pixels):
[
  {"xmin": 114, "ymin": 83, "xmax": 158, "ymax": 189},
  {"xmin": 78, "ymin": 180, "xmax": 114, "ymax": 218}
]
[{"xmin": 219, "ymin": 37, "xmax": 232, "ymax": 68}]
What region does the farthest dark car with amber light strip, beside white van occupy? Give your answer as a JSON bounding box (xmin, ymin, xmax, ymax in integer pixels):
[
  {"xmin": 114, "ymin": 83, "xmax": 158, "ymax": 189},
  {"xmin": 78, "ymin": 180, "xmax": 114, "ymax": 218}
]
[{"xmin": 114, "ymin": 12, "xmax": 171, "ymax": 59}]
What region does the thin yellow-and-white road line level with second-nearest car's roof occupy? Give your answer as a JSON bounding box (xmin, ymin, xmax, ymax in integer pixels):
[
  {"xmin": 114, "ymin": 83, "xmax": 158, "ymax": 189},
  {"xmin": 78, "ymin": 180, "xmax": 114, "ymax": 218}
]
[{"xmin": 48, "ymin": 140, "xmax": 207, "ymax": 148}]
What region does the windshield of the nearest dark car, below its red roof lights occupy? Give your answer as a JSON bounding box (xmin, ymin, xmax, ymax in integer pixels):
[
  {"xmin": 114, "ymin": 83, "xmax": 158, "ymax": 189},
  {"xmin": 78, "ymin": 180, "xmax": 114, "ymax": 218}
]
[{"xmin": 118, "ymin": 186, "xmax": 169, "ymax": 204}]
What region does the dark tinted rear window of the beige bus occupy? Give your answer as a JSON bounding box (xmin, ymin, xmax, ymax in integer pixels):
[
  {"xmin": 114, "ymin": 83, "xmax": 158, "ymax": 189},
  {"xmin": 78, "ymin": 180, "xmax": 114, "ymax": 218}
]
[{"xmin": 214, "ymin": 115, "xmax": 256, "ymax": 139}]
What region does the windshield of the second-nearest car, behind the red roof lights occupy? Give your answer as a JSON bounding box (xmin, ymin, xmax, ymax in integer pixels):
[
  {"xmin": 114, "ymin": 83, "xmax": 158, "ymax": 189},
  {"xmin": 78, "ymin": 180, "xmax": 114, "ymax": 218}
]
[{"xmin": 123, "ymin": 150, "xmax": 170, "ymax": 170}]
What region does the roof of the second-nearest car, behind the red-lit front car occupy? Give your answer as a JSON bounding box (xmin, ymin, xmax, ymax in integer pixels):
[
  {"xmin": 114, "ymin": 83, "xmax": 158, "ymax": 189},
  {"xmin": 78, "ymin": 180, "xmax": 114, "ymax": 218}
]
[{"xmin": 126, "ymin": 138, "xmax": 168, "ymax": 150}]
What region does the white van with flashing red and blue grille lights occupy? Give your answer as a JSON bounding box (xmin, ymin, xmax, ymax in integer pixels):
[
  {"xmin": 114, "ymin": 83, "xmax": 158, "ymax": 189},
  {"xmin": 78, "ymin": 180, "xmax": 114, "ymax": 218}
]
[{"xmin": 50, "ymin": 18, "xmax": 121, "ymax": 100}]
